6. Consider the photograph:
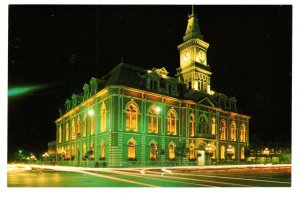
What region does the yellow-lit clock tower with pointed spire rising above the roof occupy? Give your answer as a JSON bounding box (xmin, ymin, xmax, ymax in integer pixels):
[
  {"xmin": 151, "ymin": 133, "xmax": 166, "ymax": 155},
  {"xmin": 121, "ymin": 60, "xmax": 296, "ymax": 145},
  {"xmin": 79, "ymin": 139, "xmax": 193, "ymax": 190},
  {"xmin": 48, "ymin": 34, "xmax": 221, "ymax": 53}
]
[{"xmin": 176, "ymin": 6, "xmax": 212, "ymax": 94}]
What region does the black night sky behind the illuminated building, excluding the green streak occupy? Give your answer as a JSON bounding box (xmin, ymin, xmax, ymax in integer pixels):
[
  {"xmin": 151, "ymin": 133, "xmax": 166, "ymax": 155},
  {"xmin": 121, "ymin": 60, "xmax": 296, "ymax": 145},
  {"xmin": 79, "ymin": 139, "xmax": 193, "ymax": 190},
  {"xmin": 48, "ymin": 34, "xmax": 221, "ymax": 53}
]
[{"xmin": 8, "ymin": 5, "xmax": 292, "ymax": 159}]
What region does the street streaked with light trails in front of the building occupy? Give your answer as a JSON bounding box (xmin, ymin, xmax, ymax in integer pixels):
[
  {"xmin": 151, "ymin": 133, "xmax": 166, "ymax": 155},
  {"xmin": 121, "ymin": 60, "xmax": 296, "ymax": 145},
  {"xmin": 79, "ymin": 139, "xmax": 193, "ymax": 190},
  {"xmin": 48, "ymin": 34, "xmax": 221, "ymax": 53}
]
[{"xmin": 7, "ymin": 164, "xmax": 291, "ymax": 187}]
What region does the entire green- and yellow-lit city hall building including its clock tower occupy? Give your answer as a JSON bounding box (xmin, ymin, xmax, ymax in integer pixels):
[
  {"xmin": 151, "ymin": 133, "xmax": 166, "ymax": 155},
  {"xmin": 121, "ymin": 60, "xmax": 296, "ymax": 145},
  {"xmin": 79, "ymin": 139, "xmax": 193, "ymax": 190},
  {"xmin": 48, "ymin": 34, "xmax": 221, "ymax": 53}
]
[{"xmin": 55, "ymin": 8, "xmax": 250, "ymax": 167}]
